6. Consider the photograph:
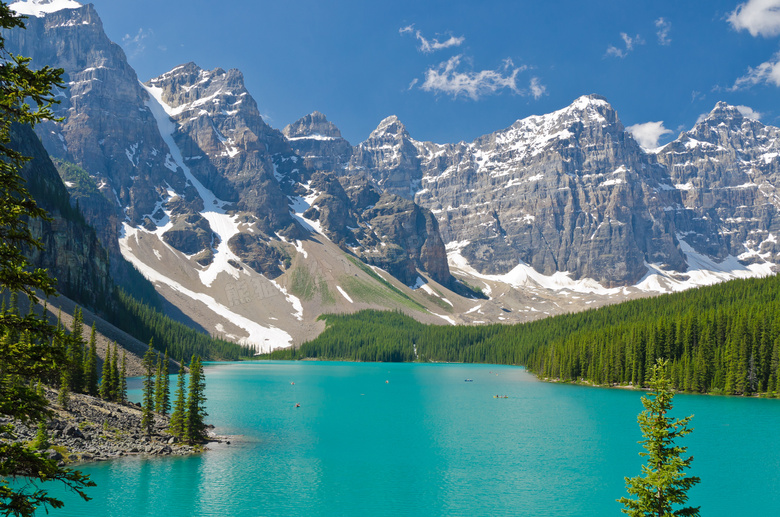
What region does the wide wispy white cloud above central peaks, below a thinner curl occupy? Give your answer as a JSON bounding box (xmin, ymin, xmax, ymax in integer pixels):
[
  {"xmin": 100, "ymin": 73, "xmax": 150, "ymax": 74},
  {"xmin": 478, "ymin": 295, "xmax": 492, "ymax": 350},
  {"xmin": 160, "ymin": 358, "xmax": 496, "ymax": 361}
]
[{"xmin": 420, "ymin": 55, "xmax": 528, "ymax": 100}]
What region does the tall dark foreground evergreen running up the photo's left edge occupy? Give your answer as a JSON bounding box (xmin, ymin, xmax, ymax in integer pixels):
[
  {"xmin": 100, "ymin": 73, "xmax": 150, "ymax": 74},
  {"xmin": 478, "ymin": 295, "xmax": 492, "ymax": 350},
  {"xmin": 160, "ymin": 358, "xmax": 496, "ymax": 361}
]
[{"xmin": 0, "ymin": 2, "xmax": 94, "ymax": 516}]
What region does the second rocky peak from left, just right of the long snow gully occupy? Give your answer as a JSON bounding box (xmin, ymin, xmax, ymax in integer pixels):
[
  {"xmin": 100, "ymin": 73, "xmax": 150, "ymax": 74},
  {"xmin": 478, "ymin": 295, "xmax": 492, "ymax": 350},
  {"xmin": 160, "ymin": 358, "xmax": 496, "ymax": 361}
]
[{"xmin": 146, "ymin": 63, "xmax": 304, "ymax": 238}]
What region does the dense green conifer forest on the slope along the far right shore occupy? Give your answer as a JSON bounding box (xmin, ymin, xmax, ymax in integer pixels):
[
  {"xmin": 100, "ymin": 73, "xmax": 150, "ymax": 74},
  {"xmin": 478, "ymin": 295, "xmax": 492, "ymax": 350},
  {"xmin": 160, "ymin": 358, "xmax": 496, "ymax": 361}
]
[{"xmin": 270, "ymin": 276, "xmax": 780, "ymax": 394}]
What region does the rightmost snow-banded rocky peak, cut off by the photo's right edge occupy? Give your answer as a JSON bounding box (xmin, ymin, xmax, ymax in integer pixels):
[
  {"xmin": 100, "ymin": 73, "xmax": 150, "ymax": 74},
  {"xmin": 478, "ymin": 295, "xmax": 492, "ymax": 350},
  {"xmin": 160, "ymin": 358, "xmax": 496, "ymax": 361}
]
[{"xmin": 657, "ymin": 102, "xmax": 780, "ymax": 263}]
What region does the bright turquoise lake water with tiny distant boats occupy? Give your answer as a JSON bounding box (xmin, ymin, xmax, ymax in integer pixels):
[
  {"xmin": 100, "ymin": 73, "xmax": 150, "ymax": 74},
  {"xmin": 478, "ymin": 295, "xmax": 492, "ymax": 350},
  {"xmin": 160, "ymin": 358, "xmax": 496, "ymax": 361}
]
[{"xmin": 35, "ymin": 362, "xmax": 780, "ymax": 517}]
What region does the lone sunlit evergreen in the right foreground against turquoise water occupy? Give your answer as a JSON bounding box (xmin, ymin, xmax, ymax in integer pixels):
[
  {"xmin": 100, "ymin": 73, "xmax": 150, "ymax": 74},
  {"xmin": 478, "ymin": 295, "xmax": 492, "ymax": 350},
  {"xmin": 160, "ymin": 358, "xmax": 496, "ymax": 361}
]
[{"xmin": 618, "ymin": 359, "xmax": 700, "ymax": 517}]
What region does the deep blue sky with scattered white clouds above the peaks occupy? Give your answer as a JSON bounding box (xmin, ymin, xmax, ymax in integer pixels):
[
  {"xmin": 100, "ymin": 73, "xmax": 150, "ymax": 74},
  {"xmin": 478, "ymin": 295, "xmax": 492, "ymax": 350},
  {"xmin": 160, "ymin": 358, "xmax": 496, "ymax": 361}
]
[{"xmin": 76, "ymin": 0, "xmax": 780, "ymax": 145}]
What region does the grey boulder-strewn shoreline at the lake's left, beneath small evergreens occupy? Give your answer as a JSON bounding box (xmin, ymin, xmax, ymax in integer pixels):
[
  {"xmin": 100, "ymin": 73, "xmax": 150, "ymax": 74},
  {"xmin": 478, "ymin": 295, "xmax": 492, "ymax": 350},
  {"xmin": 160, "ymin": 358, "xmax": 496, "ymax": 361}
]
[{"xmin": 5, "ymin": 390, "xmax": 222, "ymax": 466}]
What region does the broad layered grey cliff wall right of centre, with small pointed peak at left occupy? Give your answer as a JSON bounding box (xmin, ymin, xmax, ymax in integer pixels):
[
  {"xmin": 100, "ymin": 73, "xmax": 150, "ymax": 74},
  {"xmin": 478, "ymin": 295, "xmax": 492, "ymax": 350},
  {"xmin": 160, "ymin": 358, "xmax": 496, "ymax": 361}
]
[{"xmin": 338, "ymin": 95, "xmax": 685, "ymax": 286}]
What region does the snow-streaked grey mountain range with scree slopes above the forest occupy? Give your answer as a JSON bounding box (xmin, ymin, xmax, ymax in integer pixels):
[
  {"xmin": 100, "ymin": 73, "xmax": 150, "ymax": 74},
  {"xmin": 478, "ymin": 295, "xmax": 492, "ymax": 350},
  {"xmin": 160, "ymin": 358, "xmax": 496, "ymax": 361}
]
[{"xmin": 6, "ymin": 0, "xmax": 780, "ymax": 350}]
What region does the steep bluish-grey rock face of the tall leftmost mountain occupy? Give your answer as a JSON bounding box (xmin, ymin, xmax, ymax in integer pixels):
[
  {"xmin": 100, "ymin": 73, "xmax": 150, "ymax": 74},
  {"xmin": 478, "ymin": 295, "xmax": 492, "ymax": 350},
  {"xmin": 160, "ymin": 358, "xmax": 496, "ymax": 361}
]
[{"xmin": 5, "ymin": 4, "xmax": 184, "ymax": 282}]
